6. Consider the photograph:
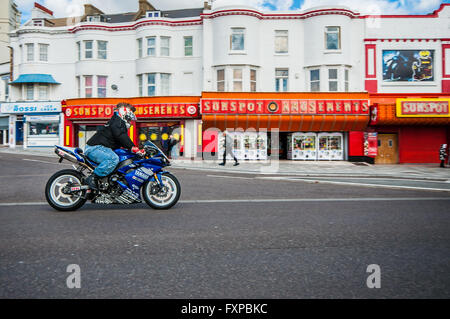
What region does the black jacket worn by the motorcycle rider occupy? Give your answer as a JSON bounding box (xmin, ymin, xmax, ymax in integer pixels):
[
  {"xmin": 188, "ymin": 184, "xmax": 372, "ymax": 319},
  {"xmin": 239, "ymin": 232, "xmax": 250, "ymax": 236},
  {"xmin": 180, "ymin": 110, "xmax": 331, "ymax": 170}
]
[{"xmin": 87, "ymin": 113, "xmax": 135, "ymax": 149}]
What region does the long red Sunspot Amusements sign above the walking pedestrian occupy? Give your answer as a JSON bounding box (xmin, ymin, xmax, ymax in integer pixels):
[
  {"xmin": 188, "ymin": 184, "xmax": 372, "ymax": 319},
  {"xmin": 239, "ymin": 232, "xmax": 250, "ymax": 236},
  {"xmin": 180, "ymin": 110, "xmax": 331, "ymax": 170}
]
[{"xmin": 201, "ymin": 99, "xmax": 369, "ymax": 115}]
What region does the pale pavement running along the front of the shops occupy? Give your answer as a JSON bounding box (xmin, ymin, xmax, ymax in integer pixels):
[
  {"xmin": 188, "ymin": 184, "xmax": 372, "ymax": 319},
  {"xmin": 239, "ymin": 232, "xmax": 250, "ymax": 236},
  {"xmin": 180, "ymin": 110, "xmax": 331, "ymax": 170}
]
[{"xmin": 0, "ymin": 147, "xmax": 450, "ymax": 181}]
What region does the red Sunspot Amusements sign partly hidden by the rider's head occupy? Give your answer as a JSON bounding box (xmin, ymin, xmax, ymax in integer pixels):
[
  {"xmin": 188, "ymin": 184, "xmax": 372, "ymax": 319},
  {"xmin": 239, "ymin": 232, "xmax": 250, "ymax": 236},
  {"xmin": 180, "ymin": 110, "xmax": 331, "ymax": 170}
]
[{"xmin": 64, "ymin": 103, "xmax": 199, "ymax": 118}]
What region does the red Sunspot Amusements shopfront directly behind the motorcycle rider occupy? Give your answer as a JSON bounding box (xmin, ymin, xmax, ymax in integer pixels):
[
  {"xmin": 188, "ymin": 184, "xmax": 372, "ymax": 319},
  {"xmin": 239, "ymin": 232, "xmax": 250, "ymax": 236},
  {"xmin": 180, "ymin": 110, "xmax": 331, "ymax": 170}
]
[{"xmin": 62, "ymin": 97, "xmax": 200, "ymax": 155}]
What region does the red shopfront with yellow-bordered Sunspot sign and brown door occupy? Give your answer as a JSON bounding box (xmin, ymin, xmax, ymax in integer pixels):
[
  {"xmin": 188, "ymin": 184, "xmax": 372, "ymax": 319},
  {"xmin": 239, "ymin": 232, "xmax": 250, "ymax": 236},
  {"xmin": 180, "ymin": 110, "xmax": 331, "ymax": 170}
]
[{"xmin": 370, "ymin": 94, "xmax": 450, "ymax": 164}]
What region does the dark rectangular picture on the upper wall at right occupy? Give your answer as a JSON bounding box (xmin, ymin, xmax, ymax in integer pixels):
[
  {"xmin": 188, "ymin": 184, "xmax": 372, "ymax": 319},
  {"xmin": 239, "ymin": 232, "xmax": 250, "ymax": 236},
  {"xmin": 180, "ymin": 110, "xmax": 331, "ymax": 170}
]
[{"xmin": 382, "ymin": 50, "xmax": 434, "ymax": 82}]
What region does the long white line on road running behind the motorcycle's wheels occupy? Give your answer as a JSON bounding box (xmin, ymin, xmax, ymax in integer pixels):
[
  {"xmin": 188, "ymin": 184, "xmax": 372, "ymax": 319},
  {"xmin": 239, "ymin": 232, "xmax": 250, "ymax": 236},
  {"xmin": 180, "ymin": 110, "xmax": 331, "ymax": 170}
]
[{"xmin": 0, "ymin": 197, "xmax": 450, "ymax": 207}]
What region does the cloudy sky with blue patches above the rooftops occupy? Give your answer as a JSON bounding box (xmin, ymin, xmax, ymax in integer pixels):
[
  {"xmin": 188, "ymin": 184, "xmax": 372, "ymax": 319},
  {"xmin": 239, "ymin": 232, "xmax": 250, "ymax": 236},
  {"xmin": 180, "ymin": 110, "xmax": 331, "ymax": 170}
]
[{"xmin": 15, "ymin": 0, "xmax": 450, "ymax": 22}]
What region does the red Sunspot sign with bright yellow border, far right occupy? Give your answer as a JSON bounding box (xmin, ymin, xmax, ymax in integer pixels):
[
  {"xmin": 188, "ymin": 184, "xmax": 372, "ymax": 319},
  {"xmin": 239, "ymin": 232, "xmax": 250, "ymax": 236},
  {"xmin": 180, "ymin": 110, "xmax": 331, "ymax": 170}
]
[{"xmin": 397, "ymin": 99, "xmax": 450, "ymax": 117}]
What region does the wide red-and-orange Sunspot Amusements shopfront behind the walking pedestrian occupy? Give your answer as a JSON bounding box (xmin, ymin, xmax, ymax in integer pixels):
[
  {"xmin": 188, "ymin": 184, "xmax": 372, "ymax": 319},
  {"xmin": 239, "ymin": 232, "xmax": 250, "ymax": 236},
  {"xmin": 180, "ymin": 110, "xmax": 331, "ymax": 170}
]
[{"xmin": 201, "ymin": 92, "xmax": 369, "ymax": 160}]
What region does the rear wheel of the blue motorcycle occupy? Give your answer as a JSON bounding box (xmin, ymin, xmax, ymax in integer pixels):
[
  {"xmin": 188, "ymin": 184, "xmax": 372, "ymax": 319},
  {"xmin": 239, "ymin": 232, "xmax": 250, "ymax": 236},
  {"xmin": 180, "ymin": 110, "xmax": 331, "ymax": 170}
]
[{"xmin": 45, "ymin": 169, "xmax": 86, "ymax": 211}]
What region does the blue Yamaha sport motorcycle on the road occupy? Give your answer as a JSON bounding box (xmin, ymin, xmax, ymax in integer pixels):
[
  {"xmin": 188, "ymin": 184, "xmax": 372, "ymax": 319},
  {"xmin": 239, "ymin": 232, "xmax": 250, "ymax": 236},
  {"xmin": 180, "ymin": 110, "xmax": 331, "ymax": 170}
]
[{"xmin": 45, "ymin": 141, "xmax": 181, "ymax": 211}]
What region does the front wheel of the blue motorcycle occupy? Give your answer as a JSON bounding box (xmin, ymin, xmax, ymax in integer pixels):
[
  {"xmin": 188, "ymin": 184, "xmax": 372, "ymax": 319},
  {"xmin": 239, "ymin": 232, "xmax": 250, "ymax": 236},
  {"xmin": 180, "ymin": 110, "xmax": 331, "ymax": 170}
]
[{"xmin": 142, "ymin": 173, "xmax": 181, "ymax": 209}]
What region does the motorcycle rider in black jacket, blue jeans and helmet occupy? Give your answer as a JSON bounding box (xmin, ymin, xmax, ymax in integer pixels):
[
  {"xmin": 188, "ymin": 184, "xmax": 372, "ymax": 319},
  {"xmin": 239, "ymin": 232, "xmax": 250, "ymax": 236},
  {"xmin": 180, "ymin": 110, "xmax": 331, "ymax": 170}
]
[{"xmin": 84, "ymin": 102, "xmax": 145, "ymax": 189}]
